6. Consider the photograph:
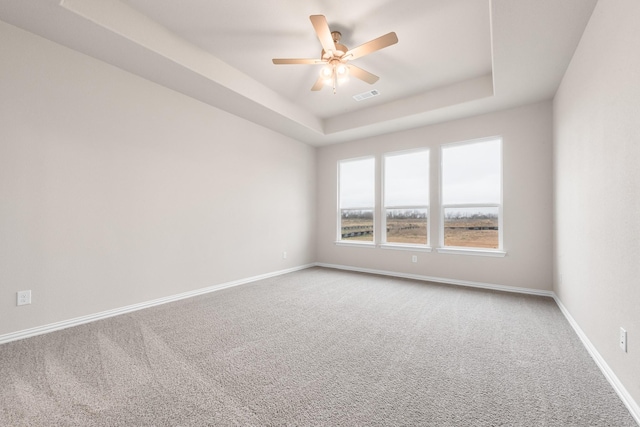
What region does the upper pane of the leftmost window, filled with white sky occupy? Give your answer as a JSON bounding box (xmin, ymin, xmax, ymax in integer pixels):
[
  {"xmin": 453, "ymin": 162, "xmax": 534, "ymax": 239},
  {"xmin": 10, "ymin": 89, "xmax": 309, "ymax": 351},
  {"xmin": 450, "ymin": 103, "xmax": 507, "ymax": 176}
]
[{"xmin": 339, "ymin": 157, "xmax": 375, "ymax": 209}]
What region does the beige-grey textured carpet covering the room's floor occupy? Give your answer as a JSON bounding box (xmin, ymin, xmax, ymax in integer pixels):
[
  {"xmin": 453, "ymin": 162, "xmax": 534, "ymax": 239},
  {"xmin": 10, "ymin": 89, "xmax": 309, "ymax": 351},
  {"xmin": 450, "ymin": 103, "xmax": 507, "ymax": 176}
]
[{"xmin": 0, "ymin": 268, "xmax": 636, "ymax": 427}]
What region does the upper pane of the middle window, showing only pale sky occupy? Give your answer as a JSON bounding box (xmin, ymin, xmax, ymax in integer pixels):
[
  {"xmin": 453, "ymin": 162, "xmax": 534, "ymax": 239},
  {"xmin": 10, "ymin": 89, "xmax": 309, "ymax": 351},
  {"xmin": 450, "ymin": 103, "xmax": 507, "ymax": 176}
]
[{"xmin": 384, "ymin": 151, "xmax": 429, "ymax": 207}]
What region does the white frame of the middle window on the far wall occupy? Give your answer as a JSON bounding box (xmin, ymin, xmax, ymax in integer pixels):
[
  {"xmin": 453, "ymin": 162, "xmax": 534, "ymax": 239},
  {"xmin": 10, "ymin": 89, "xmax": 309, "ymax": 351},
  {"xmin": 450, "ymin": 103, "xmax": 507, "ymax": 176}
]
[{"xmin": 380, "ymin": 147, "xmax": 431, "ymax": 251}]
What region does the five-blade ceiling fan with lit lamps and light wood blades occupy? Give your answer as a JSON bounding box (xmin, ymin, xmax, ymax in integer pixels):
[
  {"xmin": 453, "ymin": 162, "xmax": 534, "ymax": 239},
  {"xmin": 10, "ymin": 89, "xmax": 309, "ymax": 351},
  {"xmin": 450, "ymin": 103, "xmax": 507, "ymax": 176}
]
[{"xmin": 273, "ymin": 15, "xmax": 398, "ymax": 94}]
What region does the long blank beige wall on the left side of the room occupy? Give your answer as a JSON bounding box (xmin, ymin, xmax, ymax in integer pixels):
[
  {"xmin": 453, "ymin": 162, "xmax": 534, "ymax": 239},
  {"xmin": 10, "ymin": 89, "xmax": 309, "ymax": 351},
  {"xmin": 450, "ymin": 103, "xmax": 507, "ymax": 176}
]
[{"xmin": 0, "ymin": 22, "xmax": 315, "ymax": 335}]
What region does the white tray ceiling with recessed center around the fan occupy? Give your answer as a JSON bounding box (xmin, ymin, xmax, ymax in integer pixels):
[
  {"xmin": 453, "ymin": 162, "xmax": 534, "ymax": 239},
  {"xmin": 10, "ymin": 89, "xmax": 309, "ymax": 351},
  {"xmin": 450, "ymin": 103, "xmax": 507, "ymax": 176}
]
[{"xmin": 0, "ymin": 0, "xmax": 597, "ymax": 145}]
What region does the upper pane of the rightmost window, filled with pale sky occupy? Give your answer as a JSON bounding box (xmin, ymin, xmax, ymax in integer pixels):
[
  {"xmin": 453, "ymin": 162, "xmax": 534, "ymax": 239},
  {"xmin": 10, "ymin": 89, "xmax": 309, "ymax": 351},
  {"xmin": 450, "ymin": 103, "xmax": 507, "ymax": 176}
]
[{"xmin": 442, "ymin": 139, "xmax": 502, "ymax": 205}]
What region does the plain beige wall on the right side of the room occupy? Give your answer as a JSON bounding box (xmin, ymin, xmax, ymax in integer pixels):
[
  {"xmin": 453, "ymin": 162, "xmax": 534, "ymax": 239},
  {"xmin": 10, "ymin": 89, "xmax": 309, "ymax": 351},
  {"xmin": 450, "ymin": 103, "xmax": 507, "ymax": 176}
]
[{"xmin": 554, "ymin": 0, "xmax": 640, "ymax": 408}]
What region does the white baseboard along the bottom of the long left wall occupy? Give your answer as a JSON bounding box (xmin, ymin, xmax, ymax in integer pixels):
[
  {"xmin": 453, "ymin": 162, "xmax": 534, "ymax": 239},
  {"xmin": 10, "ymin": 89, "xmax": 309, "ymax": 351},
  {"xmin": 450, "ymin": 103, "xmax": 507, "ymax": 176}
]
[{"xmin": 0, "ymin": 264, "xmax": 315, "ymax": 344}]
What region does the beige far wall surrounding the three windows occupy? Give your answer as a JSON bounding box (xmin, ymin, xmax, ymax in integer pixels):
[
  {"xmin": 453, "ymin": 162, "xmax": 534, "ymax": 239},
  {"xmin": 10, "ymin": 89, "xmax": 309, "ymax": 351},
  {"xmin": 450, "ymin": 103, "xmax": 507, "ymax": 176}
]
[{"xmin": 317, "ymin": 102, "xmax": 552, "ymax": 290}]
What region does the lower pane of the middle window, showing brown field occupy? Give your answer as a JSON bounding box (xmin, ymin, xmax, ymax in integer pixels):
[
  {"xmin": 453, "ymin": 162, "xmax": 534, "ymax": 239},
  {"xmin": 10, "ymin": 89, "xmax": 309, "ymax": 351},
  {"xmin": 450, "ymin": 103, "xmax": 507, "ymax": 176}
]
[{"xmin": 387, "ymin": 209, "xmax": 427, "ymax": 245}]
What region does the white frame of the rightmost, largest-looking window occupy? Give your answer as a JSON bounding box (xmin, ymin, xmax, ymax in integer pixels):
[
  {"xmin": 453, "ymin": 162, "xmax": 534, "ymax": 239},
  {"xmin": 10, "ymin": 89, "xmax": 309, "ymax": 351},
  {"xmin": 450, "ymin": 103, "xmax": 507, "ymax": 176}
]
[{"xmin": 436, "ymin": 136, "xmax": 507, "ymax": 257}]
